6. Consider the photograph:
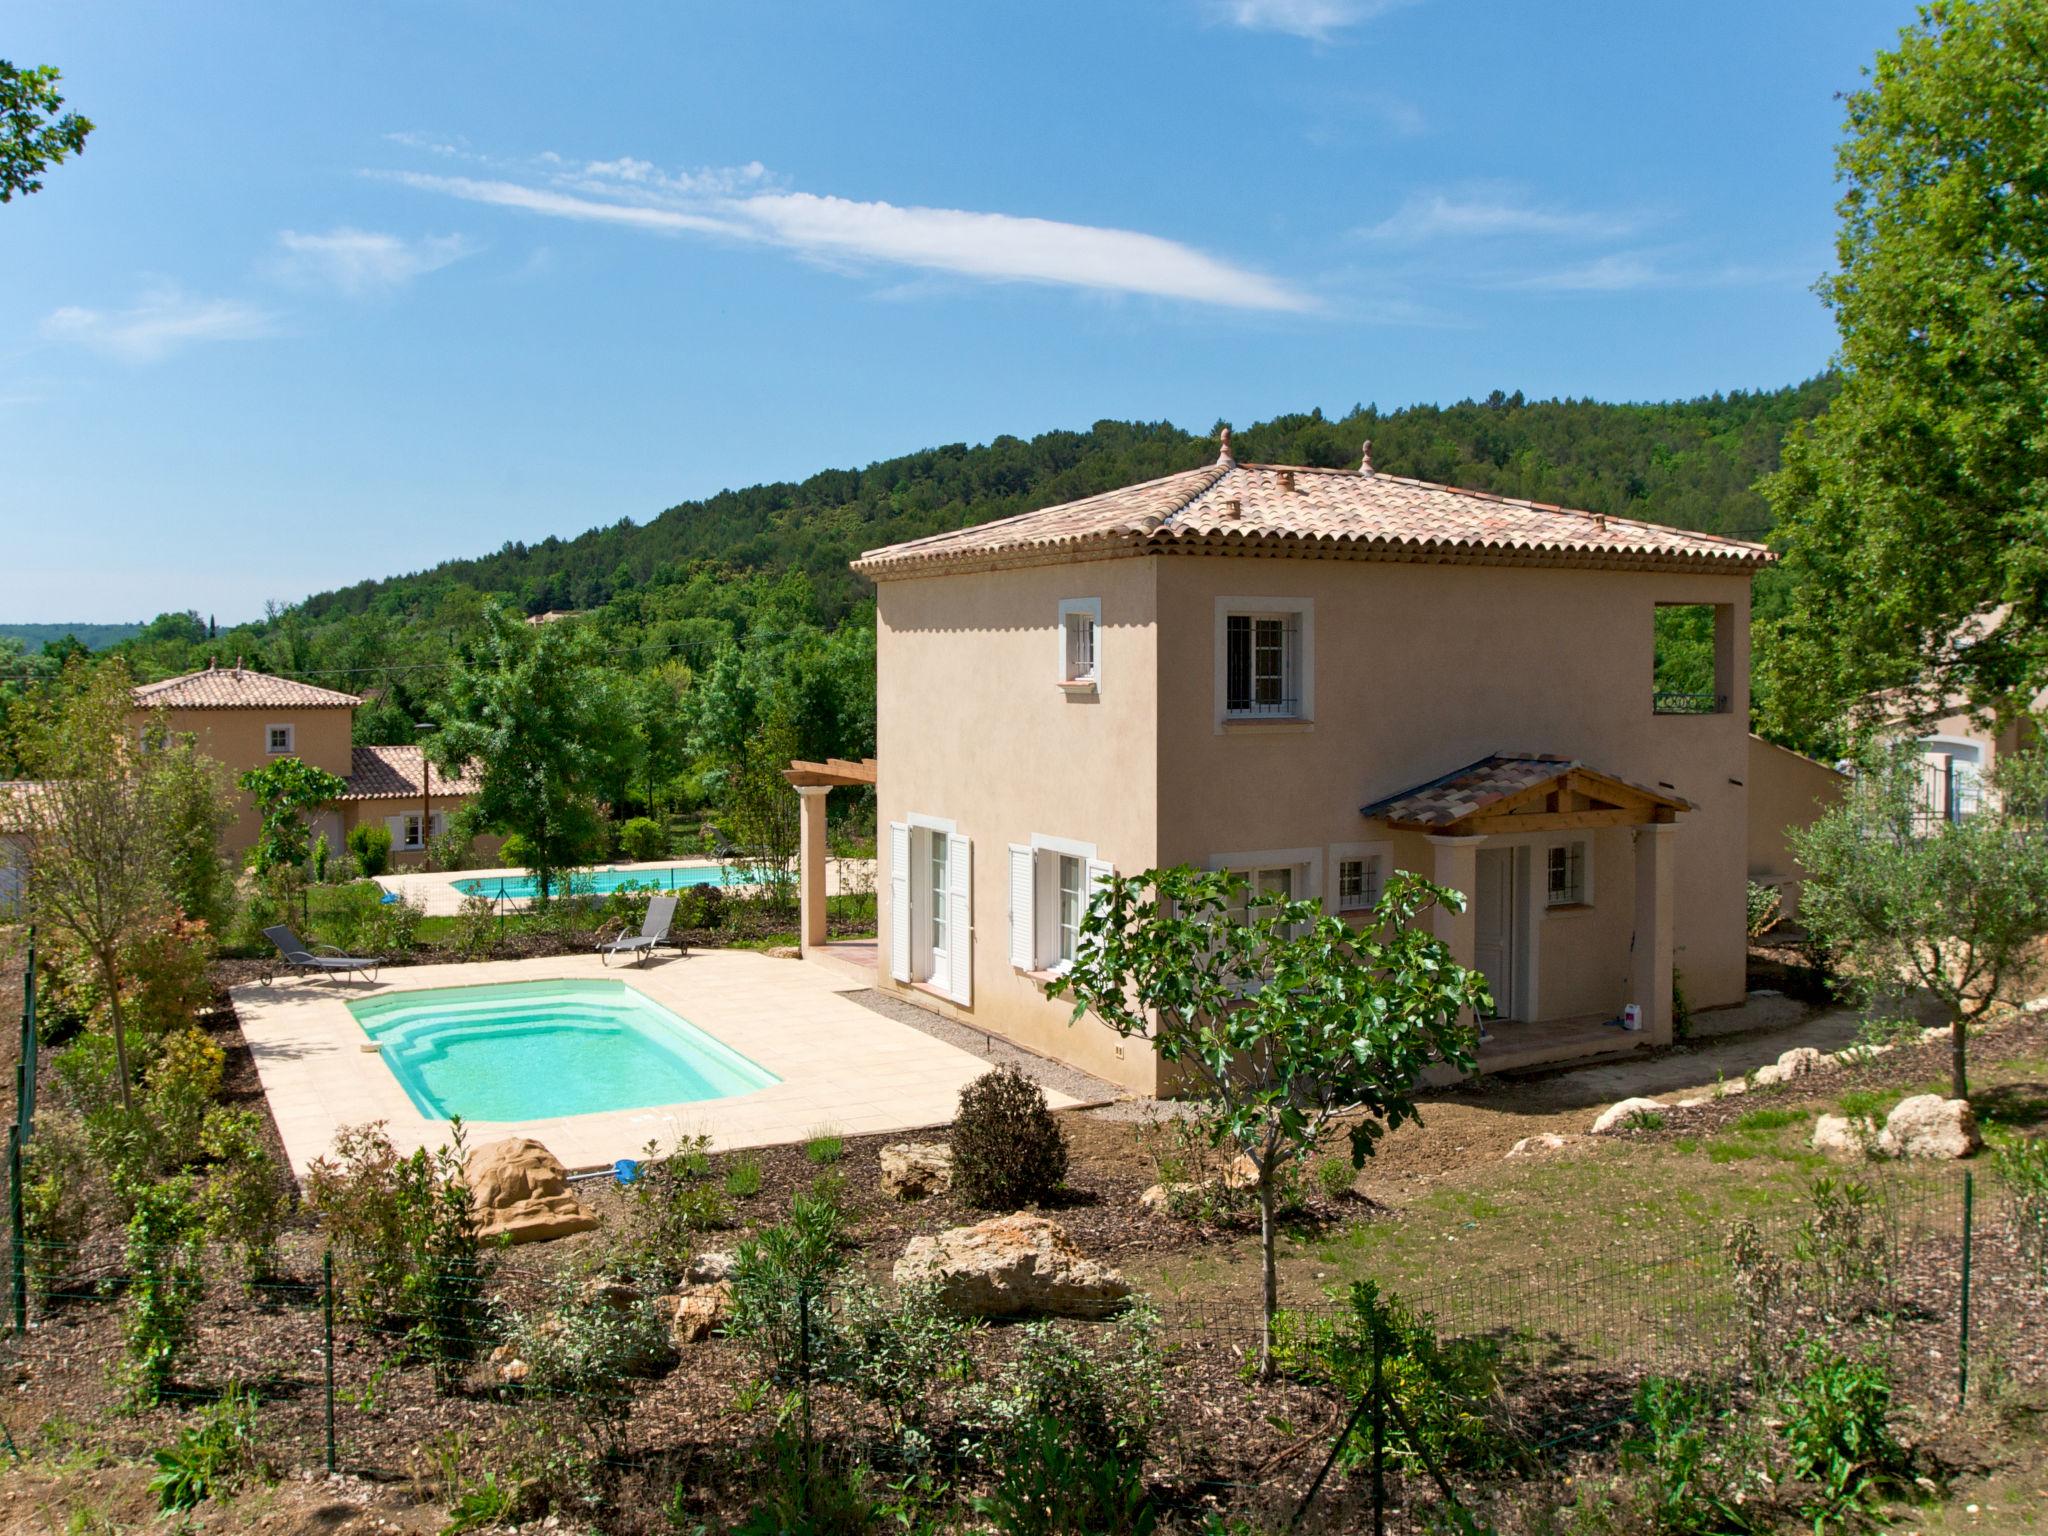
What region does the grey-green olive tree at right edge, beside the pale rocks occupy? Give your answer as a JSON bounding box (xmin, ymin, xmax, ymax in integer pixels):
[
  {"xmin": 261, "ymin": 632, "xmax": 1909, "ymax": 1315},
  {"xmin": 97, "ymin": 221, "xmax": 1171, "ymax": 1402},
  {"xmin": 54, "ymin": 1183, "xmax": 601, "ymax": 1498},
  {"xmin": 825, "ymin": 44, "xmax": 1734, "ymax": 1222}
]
[{"xmin": 1792, "ymin": 745, "xmax": 2048, "ymax": 1098}]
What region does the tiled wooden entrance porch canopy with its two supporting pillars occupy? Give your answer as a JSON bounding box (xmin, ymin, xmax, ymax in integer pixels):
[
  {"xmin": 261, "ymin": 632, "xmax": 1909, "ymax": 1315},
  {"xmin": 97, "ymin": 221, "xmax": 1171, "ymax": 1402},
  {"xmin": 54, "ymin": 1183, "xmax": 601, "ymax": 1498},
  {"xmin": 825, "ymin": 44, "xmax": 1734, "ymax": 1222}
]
[{"xmin": 1360, "ymin": 754, "xmax": 1692, "ymax": 1044}]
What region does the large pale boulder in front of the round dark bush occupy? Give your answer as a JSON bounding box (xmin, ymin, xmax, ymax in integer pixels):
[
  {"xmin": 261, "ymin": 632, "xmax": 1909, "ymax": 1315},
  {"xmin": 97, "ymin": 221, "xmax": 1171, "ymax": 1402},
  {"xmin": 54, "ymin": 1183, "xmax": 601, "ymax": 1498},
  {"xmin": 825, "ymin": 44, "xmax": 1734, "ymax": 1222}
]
[{"xmin": 895, "ymin": 1212, "xmax": 1130, "ymax": 1317}]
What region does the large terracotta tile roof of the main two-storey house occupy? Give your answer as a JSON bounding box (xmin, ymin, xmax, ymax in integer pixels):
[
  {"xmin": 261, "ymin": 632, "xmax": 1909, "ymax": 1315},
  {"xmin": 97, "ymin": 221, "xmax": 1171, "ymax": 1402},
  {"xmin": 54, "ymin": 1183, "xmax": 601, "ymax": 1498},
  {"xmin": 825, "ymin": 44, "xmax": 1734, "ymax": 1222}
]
[{"xmin": 854, "ymin": 459, "xmax": 1776, "ymax": 578}]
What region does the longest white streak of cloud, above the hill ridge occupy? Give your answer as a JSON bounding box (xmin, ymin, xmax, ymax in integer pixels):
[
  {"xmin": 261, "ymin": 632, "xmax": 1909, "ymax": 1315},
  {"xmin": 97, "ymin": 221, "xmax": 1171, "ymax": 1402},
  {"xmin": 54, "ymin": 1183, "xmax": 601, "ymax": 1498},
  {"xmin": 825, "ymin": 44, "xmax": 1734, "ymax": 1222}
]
[{"xmin": 391, "ymin": 156, "xmax": 1315, "ymax": 311}]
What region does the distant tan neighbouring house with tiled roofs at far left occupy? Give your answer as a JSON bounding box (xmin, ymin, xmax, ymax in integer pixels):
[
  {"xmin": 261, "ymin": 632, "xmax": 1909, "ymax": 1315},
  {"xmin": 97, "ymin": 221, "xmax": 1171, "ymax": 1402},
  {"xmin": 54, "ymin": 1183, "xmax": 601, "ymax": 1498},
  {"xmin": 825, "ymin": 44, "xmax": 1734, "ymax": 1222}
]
[{"xmin": 135, "ymin": 664, "xmax": 500, "ymax": 864}]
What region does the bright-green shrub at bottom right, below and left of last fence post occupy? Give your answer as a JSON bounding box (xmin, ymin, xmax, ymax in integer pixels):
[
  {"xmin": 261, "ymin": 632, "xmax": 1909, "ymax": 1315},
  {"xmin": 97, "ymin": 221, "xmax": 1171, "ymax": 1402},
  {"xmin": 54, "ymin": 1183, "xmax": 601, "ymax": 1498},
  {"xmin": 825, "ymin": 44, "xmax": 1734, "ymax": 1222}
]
[{"xmin": 1778, "ymin": 1339, "xmax": 1913, "ymax": 1530}]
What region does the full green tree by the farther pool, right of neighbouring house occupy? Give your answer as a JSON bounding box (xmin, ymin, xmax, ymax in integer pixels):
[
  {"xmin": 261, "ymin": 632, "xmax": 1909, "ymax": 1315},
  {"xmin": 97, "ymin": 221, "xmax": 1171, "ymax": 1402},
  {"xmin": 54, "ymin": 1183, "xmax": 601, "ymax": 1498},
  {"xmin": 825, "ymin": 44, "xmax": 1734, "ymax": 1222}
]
[{"xmin": 442, "ymin": 608, "xmax": 633, "ymax": 897}]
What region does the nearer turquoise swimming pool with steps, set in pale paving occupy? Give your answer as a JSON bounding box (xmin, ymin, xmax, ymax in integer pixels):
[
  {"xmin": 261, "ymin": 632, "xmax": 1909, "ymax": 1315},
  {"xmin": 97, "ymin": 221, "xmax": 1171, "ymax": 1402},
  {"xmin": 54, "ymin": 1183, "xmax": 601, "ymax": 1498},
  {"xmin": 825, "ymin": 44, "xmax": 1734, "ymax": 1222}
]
[{"xmin": 348, "ymin": 979, "xmax": 782, "ymax": 1120}]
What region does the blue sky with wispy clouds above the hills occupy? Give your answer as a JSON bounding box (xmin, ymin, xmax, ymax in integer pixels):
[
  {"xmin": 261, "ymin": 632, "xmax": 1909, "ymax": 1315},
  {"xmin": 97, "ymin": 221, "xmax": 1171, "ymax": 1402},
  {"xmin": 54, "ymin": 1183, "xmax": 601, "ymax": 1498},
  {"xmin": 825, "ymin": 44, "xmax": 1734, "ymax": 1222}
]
[{"xmin": 0, "ymin": 0, "xmax": 1911, "ymax": 621}]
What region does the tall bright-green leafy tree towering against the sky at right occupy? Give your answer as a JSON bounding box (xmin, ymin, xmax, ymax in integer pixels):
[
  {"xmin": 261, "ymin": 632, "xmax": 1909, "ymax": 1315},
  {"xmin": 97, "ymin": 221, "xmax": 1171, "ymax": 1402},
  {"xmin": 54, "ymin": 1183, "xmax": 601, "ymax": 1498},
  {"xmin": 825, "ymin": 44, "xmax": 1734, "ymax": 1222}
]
[{"xmin": 1759, "ymin": 0, "xmax": 2048, "ymax": 745}]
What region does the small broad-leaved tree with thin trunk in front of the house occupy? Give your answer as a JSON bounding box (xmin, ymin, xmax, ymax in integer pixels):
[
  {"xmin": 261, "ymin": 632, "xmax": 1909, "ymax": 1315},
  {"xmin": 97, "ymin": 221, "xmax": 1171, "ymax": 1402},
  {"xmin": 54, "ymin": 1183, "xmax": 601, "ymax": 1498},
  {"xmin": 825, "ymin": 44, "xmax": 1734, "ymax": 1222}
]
[{"xmin": 1047, "ymin": 864, "xmax": 1487, "ymax": 1376}]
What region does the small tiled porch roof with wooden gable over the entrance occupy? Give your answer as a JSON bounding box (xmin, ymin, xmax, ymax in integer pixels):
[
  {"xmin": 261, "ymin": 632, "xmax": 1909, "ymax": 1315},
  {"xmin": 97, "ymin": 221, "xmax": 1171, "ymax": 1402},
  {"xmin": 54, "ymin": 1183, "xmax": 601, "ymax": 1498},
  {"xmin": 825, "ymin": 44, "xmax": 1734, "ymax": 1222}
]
[{"xmin": 1358, "ymin": 752, "xmax": 1692, "ymax": 836}]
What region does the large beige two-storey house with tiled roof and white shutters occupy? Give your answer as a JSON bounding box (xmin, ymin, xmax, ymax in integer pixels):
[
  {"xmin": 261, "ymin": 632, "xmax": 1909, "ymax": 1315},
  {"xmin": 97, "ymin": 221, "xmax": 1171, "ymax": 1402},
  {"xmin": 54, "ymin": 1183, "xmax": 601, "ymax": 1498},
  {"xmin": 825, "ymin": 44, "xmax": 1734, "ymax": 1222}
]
[{"xmin": 854, "ymin": 434, "xmax": 1772, "ymax": 1092}]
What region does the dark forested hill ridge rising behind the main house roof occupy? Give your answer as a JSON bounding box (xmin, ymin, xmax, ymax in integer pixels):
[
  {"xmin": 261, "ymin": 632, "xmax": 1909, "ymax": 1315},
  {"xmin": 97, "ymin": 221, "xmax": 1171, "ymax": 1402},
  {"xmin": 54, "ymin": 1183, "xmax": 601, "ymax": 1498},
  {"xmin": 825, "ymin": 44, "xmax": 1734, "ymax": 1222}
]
[{"xmin": 301, "ymin": 377, "xmax": 1835, "ymax": 621}]
